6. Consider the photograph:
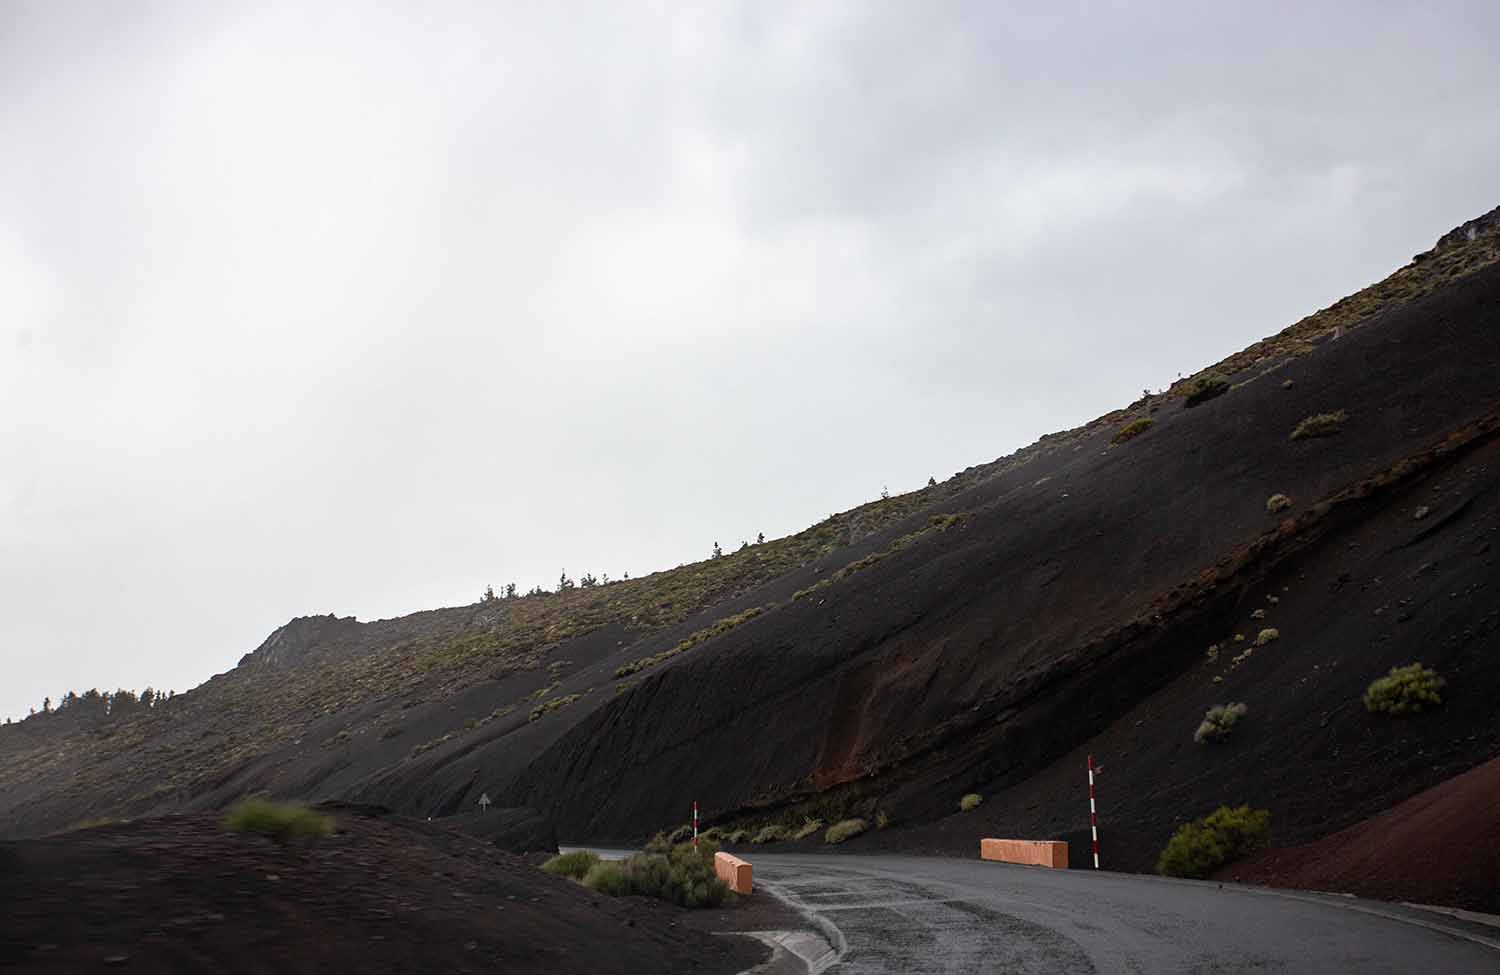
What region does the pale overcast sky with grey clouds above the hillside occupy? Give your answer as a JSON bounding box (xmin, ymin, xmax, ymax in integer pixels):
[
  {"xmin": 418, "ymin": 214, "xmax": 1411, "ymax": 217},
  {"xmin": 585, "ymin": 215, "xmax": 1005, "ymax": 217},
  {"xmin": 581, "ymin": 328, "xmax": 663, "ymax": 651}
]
[{"xmin": 0, "ymin": 0, "xmax": 1500, "ymax": 716}]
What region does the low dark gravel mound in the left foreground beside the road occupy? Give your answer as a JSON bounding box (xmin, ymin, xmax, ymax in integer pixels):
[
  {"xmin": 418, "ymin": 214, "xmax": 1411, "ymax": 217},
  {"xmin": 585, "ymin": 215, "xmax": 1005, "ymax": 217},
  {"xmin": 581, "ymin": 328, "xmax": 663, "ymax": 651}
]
[{"xmin": 0, "ymin": 810, "xmax": 767, "ymax": 975}]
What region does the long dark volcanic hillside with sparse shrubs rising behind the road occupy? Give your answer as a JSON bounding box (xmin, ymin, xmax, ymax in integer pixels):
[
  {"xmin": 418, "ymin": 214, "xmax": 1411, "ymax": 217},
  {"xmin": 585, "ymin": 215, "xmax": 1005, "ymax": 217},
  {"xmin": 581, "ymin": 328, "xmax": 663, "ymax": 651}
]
[{"xmin": 0, "ymin": 210, "xmax": 1500, "ymax": 912}]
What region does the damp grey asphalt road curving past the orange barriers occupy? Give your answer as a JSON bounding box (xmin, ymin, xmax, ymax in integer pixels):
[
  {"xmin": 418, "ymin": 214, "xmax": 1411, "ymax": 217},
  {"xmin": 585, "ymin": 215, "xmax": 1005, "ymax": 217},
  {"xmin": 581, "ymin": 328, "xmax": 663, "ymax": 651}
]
[{"xmin": 749, "ymin": 855, "xmax": 1500, "ymax": 975}]
